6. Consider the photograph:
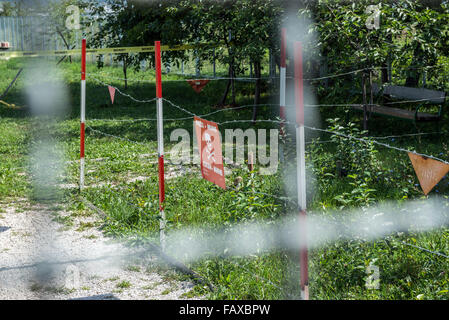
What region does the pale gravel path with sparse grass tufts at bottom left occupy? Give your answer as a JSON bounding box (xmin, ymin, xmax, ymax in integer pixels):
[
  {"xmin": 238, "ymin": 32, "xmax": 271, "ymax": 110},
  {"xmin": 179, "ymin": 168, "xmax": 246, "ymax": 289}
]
[{"xmin": 0, "ymin": 199, "xmax": 198, "ymax": 300}]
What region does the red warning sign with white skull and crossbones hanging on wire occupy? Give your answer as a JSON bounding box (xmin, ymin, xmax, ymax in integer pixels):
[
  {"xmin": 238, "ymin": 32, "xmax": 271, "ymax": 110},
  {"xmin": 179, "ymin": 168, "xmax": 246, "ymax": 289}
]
[{"xmin": 194, "ymin": 117, "xmax": 226, "ymax": 189}]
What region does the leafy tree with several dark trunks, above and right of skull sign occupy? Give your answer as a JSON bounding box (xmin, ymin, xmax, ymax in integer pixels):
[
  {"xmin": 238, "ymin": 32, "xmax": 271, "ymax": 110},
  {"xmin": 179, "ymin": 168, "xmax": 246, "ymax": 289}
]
[{"xmin": 191, "ymin": 0, "xmax": 282, "ymax": 110}]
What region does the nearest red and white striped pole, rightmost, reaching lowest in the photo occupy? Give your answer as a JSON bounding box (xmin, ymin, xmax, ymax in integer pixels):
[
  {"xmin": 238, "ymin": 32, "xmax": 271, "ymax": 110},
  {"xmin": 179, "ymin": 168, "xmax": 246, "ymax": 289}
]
[{"xmin": 295, "ymin": 42, "xmax": 309, "ymax": 300}]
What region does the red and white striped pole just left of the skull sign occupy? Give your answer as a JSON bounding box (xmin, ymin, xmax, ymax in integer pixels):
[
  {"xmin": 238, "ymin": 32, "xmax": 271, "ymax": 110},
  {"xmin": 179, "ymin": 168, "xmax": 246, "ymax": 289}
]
[{"xmin": 154, "ymin": 41, "xmax": 166, "ymax": 250}]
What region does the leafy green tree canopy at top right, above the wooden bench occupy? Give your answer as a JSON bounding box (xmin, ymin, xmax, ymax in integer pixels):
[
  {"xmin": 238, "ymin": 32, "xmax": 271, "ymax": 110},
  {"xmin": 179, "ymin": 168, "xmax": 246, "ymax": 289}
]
[{"xmin": 299, "ymin": 0, "xmax": 448, "ymax": 90}]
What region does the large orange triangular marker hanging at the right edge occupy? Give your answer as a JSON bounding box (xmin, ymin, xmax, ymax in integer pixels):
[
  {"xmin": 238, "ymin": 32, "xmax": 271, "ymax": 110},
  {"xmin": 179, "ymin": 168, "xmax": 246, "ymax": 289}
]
[{"xmin": 408, "ymin": 152, "xmax": 449, "ymax": 195}]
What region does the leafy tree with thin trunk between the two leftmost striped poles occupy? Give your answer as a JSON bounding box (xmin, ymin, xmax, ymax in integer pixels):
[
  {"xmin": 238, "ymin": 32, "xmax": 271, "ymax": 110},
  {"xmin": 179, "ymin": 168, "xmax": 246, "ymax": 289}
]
[{"xmin": 89, "ymin": 0, "xmax": 190, "ymax": 87}]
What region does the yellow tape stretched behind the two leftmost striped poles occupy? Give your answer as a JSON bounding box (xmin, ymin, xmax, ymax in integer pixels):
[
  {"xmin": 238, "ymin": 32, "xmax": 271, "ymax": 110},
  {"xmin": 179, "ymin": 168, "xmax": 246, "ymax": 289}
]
[{"xmin": 0, "ymin": 44, "xmax": 220, "ymax": 59}]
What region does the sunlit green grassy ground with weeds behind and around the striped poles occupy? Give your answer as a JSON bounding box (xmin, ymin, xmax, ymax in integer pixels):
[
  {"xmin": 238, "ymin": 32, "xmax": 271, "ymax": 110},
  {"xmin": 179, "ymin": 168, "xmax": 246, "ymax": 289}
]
[{"xmin": 0, "ymin": 55, "xmax": 449, "ymax": 299}]
